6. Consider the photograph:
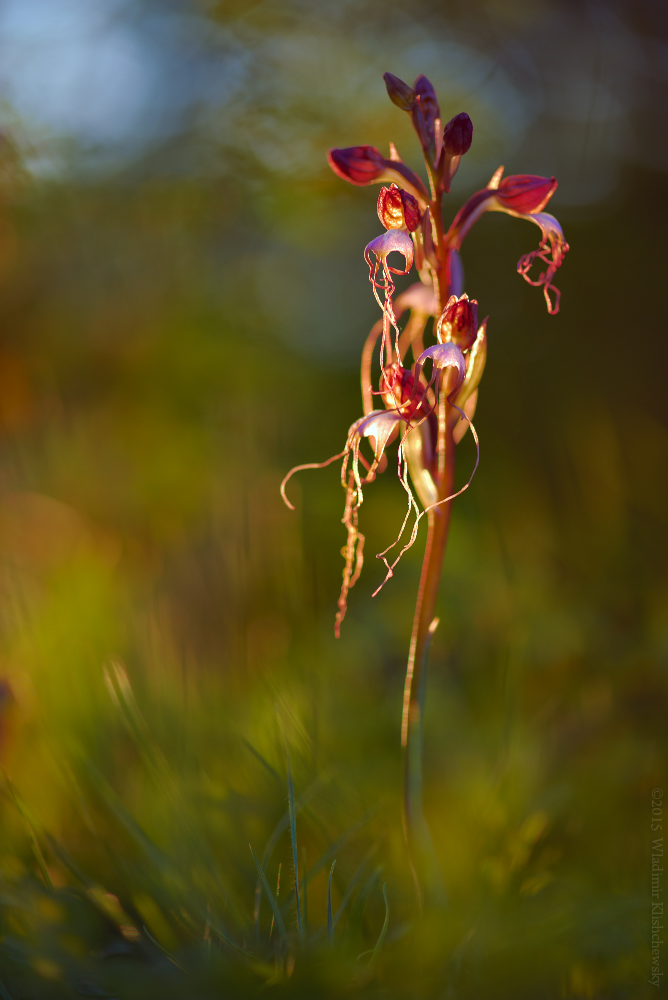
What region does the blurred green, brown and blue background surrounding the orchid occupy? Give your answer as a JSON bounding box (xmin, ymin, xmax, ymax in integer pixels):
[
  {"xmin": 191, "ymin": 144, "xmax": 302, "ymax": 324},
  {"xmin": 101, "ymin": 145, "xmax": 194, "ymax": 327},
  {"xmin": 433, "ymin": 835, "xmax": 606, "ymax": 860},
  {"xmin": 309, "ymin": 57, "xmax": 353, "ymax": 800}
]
[{"xmin": 0, "ymin": 0, "xmax": 668, "ymax": 1000}]
